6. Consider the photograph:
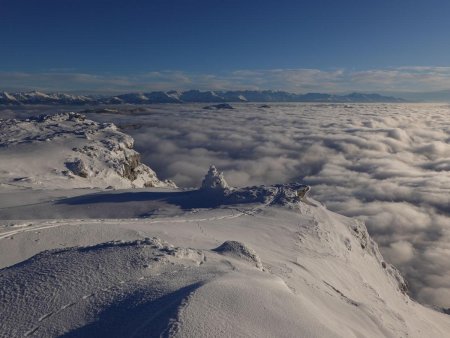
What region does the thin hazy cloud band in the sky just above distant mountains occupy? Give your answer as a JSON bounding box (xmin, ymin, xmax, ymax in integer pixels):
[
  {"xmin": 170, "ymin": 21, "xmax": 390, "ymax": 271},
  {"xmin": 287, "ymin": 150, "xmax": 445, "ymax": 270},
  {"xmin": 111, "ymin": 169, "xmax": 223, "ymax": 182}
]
[{"xmin": 4, "ymin": 67, "xmax": 450, "ymax": 94}]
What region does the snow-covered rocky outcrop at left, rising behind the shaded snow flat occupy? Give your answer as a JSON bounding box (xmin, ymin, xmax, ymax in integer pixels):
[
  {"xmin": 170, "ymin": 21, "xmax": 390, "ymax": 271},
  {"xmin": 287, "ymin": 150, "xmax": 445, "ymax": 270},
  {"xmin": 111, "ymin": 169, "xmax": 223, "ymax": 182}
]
[{"xmin": 0, "ymin": 113, "xmax": 174, "ymax": 189}]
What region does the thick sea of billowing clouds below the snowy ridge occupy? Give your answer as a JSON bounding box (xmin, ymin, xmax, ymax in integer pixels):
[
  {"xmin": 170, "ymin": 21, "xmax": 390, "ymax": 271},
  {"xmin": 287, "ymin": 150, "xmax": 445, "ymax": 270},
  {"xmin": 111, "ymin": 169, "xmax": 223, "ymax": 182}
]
[{"xmin": 3, "ymin": 104, "xmax": 450, "ymax": 308}]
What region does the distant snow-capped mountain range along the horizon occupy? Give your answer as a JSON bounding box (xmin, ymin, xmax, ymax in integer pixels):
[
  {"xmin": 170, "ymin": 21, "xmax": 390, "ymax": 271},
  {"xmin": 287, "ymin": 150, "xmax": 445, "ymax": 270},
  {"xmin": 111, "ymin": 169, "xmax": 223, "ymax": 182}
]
[{"xmin": 0, "ymin": 90, "xmax": 404, "ymax": 105}]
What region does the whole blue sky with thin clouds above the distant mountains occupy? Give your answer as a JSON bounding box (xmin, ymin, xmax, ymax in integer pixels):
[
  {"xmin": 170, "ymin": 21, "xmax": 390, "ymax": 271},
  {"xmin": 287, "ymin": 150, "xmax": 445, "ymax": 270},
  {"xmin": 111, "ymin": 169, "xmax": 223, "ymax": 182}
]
[{"xmin": 0, "ymin": 0, "xmax": 450, "ymax": 92}]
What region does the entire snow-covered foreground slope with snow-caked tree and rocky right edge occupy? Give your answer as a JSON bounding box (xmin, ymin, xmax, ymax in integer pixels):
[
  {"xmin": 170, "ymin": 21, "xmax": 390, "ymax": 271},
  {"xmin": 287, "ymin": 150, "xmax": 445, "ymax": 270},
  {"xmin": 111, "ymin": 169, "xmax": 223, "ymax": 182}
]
[{"xmin": 0, "ymin": 167, "xmax": 450, "ymax": 337}]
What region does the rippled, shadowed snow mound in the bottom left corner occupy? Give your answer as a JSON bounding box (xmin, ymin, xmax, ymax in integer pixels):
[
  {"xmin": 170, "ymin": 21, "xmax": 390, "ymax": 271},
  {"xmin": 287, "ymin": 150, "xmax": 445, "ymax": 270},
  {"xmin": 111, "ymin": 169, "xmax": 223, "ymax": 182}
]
[{"xmin": 0, "ymin": 238, "xmax": 208, "ymax": 337}]
